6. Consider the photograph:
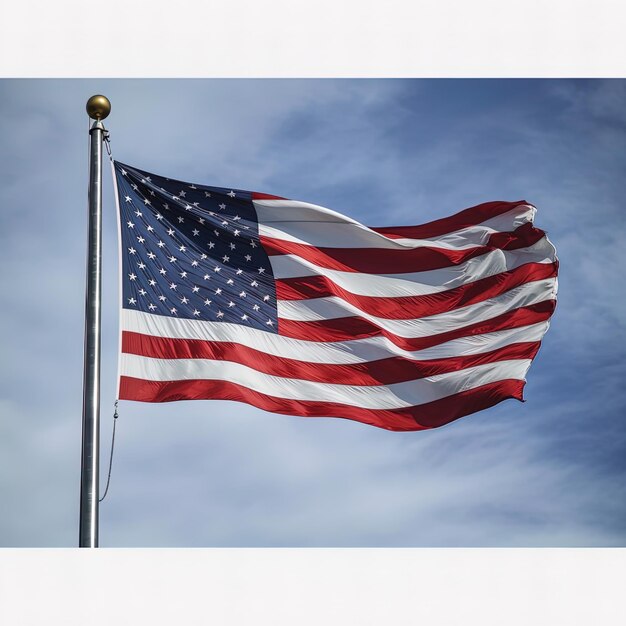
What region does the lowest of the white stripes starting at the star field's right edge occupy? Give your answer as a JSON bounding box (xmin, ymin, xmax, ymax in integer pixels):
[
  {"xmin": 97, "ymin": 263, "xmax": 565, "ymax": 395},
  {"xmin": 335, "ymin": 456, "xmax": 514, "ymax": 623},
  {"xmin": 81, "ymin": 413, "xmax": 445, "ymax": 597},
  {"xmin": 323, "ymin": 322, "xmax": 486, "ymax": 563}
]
[{"xmin": 278, "ymin": 278, "xmax": 556, "ymax": 337}]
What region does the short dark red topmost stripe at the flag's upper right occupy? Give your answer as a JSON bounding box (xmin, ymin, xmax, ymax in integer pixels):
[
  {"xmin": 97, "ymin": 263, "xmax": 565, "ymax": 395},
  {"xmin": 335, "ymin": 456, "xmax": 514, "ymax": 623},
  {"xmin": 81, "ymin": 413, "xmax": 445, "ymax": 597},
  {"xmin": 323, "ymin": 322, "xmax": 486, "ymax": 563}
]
[{"xmin": 372, "ymin": 200, "xmax": 528, "ymax": 239}]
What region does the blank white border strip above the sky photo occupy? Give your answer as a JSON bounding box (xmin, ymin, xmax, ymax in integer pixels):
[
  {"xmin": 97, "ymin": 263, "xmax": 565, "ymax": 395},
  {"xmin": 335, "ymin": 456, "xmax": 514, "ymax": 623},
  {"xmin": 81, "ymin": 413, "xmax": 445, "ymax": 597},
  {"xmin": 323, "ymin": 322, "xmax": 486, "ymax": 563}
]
[{"xmin": 0, "ymin": 0, "xmax": 626, "ymax": 78}]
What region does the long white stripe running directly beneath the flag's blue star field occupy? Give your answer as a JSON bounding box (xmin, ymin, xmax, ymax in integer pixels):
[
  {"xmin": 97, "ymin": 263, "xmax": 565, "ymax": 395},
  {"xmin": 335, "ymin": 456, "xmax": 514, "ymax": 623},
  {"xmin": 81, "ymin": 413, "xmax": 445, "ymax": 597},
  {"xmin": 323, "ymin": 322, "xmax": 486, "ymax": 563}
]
[{"xmin": 122, "ymin": 309, "xmax": 548, "ymax": 364}]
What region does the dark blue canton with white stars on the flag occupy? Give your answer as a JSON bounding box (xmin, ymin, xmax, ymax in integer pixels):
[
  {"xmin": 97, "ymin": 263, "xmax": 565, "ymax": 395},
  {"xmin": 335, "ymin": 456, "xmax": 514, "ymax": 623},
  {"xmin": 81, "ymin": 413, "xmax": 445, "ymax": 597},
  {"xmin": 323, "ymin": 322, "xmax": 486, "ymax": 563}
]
[{"xmin": 115, "ymin": 161, "xmax": 278, "ymax": 333}]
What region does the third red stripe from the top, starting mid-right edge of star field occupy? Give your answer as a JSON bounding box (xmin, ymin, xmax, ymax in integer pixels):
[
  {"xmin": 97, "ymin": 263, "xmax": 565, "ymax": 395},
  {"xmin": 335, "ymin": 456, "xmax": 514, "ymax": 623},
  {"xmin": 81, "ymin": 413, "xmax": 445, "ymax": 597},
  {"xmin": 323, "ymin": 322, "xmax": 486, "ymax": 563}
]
[{"xmin": 276, "ymin": 263, "xmax": 557, "ymax": 320}]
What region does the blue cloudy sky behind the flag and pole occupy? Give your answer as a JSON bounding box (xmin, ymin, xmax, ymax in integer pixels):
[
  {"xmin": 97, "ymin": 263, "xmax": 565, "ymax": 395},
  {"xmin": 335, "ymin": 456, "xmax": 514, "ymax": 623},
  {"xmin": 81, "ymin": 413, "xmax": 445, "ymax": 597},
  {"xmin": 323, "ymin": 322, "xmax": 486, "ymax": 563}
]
[{"xmin": 0, "ymin": 79, "xmax": 626, "ymax": 547}]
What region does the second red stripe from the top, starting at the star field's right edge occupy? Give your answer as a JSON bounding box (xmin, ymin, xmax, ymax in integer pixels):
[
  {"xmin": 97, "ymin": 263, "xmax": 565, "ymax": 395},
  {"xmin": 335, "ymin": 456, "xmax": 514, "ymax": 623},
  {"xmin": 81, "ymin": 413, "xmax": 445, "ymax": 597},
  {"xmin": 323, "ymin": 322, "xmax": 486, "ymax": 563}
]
[{"xmin": 261, "ymin": 223, "xmax": 544, "ymax": 274}]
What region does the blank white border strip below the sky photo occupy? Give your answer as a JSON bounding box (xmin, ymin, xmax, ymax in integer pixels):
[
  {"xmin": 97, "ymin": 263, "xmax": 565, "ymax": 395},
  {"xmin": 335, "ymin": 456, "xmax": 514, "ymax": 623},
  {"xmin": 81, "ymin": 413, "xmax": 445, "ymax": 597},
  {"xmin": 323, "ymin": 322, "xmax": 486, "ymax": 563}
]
[{"xmin": 0, "ymin": 548, "xmax": 626, "ymax": 626}]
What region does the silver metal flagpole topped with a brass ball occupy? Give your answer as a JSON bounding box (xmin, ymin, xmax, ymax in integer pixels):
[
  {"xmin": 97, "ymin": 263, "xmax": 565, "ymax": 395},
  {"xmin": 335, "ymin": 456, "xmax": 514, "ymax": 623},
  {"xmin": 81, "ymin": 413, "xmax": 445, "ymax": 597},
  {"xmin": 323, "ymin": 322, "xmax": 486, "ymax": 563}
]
[{"xmin": 79, "ymin": 95, "xmax": 111, "ymax": 548}]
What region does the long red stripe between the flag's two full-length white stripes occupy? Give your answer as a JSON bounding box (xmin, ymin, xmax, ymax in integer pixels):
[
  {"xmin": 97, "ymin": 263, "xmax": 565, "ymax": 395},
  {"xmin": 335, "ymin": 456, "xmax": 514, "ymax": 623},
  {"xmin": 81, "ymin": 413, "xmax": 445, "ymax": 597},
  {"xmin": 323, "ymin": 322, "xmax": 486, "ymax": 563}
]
[{"xmin": 122, "ymin": 331, "xmax": 540, "ymax": 386}]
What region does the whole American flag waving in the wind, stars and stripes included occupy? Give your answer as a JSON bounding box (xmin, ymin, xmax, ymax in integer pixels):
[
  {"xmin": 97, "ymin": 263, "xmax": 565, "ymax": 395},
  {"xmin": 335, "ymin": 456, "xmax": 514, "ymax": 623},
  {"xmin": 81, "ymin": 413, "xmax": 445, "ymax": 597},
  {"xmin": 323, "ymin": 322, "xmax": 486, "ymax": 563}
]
[{"xmin": 114, "ymin": 162, "xmax": 558, "ymax": 430}]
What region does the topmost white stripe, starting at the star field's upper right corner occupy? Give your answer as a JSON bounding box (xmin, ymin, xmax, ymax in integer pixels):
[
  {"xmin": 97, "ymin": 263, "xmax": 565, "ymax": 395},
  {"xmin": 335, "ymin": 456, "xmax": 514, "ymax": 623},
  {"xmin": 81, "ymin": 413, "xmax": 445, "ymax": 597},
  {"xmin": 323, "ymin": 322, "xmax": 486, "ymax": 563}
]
[{"xmin": 254, "ymin": 200, "xmax": 537, "ymax": 250}]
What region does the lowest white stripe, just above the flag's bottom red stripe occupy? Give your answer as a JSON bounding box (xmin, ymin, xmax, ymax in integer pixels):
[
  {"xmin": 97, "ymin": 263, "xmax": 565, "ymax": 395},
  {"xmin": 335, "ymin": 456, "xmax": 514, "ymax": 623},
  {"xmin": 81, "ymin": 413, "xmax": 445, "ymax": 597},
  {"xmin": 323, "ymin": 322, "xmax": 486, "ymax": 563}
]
[{"xmin": 122, "ymin": 354, "xmax": 532, "ymax": 409}]
